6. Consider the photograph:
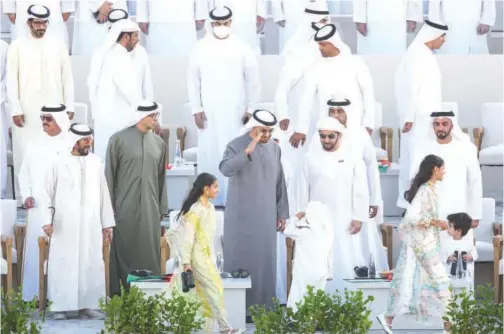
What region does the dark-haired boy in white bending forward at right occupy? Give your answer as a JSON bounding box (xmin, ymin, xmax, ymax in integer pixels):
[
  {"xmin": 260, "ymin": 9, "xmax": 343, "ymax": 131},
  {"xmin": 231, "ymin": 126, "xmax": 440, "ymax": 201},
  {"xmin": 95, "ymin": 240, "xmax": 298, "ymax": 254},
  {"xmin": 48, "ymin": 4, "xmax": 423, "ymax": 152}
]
[{"xmin": 441, "ymin": 212, "xmax": 478, "ymax": 284}]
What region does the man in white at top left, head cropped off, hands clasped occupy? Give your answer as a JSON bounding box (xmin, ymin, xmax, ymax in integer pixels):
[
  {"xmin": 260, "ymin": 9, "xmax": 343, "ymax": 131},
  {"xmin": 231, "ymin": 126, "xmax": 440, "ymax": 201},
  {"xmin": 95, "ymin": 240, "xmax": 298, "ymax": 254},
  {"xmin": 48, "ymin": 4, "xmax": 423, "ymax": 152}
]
[{"xmin": 72, "ymin": 0, "xmax": 129, "ymax": 56}]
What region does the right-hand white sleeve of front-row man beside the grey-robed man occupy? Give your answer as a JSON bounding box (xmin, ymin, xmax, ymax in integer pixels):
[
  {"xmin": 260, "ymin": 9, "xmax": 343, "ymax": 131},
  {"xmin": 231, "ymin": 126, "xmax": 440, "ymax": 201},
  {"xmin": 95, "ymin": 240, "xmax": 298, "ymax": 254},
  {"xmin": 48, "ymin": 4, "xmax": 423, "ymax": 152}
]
[{"xmin": 352, "ymin": 160, "xmax": 369, "ymax": 222}]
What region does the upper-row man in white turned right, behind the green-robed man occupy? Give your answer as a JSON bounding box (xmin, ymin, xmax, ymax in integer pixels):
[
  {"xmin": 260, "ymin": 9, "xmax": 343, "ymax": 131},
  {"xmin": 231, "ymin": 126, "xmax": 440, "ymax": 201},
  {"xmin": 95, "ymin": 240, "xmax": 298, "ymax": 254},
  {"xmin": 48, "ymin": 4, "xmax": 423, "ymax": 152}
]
[{"xmin": 88, "ymin": 19, "xmax": 142, "ymax": 160}]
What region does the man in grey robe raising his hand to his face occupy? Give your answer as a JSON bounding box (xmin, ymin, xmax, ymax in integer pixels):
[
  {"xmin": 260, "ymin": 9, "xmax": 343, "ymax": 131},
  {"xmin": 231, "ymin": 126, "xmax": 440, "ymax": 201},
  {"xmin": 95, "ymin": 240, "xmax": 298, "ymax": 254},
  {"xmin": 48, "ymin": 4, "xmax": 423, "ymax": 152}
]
[{"xmin": 219, "ymin": 110, "xmax": 289, "ymax": 308}]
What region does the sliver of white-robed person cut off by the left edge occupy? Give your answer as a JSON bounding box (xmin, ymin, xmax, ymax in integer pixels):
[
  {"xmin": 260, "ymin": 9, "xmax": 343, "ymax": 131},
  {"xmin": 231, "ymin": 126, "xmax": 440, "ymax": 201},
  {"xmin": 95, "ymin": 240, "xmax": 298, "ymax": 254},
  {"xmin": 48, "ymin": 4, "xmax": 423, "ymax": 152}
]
[{"xmin": 0, "ymin": 40, "xmax": 7, "ymax": 199}]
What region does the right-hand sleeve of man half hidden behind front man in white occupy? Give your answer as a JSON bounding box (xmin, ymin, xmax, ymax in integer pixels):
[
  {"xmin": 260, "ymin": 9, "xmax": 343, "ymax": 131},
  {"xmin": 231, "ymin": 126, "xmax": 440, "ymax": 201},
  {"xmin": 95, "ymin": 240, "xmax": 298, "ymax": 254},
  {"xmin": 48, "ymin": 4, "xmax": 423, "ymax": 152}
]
[{"xmin": 362, "ymin": 130, "xmax": 382, "ymax": 206}]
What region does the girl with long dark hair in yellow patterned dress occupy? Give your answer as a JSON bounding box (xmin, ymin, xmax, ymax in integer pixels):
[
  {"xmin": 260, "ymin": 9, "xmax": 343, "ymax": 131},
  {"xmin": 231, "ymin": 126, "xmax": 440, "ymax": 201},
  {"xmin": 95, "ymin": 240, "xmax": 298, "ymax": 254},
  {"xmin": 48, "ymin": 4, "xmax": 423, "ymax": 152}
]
[{"xmin": 177, "ymin": 173, "xmax": 244, "ymax": 334}]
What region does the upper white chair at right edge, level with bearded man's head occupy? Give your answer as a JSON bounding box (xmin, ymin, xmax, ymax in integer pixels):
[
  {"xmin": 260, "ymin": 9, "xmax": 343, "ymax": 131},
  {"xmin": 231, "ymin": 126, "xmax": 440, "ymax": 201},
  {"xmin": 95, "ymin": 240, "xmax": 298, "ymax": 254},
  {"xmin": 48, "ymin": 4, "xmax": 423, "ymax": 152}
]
[{"xmin": 479, "ymin": 102, "xmax": 504, "ymax": 166}]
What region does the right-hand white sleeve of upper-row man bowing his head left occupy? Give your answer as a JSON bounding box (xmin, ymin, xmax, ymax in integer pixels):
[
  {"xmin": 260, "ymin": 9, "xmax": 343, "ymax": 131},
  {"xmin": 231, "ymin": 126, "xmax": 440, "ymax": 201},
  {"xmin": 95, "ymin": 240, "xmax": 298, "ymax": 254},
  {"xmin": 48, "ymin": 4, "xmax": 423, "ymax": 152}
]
[{"xmin": 354, "ymin": 56, "xmax": 376, "ymax": 129}]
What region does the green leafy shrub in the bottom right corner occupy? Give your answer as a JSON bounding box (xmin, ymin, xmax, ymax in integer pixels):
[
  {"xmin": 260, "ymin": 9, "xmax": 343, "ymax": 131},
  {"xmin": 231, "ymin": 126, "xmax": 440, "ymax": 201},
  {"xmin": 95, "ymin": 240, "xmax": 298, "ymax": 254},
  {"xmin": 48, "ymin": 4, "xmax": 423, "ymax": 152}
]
[{"xmin": 443, "ymin": 286, "xmax": 504, "ymax": 334}]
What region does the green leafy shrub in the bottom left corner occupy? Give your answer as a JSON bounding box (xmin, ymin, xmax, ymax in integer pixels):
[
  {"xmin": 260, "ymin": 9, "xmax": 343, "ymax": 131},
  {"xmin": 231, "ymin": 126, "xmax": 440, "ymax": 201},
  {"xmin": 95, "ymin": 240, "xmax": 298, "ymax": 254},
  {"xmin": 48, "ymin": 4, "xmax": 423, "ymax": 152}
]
[{"xmin": 0, "ymin": 287, "xmax": 45, "ymax": 334}]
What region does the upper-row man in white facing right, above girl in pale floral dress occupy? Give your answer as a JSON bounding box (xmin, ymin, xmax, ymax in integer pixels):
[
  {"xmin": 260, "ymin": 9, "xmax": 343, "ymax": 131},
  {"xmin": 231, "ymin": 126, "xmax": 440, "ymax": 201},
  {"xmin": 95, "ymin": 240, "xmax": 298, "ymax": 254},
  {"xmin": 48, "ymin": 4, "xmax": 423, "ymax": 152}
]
[{"xmin": 394, "ymin": 21, "xmax": 448, "ymax": 208}]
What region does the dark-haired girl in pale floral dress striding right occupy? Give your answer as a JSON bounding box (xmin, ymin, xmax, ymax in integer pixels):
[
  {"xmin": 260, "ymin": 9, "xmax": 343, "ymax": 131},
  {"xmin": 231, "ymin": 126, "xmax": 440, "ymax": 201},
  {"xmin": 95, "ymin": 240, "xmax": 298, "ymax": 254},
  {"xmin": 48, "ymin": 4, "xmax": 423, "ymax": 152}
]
[{"xmin": 378, "ymin": 155, "xmax": 451, "ymax": 334}]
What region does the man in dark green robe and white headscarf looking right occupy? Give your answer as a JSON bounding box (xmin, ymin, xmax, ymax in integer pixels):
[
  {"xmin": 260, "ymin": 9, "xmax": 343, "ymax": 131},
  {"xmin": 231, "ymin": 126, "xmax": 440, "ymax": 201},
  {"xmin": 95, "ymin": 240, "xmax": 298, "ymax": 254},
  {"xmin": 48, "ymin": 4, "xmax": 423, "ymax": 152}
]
[{"xmin": 105, "ymin": 102, "xmax": 168, "ymax": 295}]
